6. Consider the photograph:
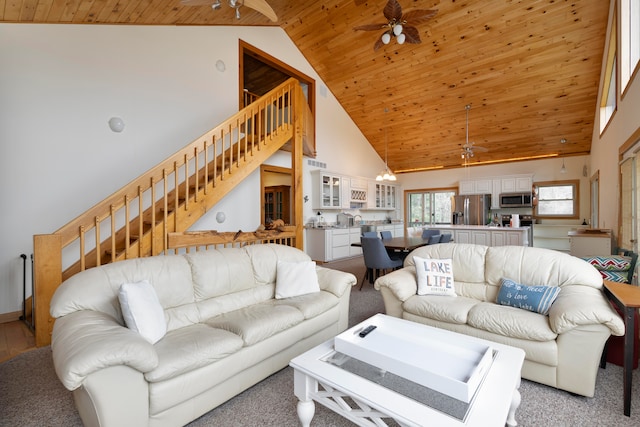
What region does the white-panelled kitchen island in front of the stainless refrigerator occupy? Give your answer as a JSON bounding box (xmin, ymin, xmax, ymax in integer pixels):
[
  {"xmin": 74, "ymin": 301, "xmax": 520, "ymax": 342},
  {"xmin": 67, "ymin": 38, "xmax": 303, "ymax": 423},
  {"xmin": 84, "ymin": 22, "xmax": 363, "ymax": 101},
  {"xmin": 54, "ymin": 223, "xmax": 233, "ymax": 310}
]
[{"xmin": 424, "ymin": 225, "xmax": 530, "ymax": 246}]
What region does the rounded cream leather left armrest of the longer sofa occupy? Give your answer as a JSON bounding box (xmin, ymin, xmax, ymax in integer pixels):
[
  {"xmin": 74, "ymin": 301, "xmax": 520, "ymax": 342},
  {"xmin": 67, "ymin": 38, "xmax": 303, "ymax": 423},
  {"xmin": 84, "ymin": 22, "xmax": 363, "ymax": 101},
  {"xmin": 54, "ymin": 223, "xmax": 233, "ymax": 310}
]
[{"xmin": 51, "ymin": 310, "xmax": 158, "ymax": 390}]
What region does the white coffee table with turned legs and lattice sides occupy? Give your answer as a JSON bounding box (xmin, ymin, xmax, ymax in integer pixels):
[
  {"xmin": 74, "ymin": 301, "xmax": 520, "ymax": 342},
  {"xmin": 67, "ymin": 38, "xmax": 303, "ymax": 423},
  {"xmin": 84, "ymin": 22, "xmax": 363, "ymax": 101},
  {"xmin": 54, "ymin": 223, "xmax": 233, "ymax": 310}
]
[{"xmin": 290, "ymin": 314, "xmax": 524, "ymax": 427}]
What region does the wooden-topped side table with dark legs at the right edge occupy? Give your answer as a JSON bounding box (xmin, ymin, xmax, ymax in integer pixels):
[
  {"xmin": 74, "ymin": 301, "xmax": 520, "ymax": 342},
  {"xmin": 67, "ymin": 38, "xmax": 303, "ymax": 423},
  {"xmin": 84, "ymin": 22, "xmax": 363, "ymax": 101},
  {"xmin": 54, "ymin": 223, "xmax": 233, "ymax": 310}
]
[{"xmin": 604, "ymin": 280, "xmax": 640, "ymax": 417}]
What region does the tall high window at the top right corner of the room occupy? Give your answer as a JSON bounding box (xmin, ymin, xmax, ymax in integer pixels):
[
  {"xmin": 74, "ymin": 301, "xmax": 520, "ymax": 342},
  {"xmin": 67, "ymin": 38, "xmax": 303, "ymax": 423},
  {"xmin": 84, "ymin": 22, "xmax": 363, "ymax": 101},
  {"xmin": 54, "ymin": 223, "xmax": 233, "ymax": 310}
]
[{"xmin": 620, "ymin": 0, "xmax": 640, "ymax": 92}]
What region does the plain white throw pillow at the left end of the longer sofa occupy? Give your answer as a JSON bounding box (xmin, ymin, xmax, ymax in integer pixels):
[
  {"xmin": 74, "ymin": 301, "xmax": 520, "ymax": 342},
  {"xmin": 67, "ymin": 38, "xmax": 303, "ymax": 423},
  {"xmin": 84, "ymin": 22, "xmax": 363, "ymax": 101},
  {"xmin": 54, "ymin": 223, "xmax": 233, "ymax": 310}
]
[{"xmin": 118, "ymin": 280, "xmax": 167, "ymax": 344}]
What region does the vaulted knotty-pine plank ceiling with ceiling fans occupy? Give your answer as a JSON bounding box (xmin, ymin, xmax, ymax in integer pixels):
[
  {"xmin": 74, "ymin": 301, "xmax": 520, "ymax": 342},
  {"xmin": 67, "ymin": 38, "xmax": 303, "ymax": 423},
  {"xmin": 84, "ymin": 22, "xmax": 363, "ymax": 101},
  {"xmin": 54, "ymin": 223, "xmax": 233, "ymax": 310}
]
[{"xmin": 0, "ymin": 0, "xmax": 609, "ymax": 173}]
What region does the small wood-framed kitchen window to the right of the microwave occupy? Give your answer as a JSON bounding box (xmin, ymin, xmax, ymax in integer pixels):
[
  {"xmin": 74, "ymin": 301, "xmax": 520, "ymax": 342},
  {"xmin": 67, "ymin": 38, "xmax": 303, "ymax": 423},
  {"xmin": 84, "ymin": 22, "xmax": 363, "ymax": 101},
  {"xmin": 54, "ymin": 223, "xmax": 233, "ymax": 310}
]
[{"xmin": 534, "ymin": 180, "xmax": 580, "ymax": 219}]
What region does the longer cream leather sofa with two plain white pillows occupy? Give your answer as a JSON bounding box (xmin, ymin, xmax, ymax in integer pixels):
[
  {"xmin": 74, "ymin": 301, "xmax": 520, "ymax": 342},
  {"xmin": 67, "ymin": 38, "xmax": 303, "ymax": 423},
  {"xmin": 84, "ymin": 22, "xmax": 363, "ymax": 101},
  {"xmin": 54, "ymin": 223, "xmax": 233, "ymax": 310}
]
[{"xmin": 51, "ymin": 244, "xmax": 356, "ymax": 427}]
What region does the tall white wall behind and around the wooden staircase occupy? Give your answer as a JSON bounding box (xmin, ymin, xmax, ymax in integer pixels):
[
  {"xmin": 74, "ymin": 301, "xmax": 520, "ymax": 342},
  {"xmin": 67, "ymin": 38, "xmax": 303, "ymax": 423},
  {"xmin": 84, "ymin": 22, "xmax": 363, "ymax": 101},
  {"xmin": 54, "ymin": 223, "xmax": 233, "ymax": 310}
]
[{"xmin": 0, "ymin": 24, "xmax": 384, "ymax": 314}]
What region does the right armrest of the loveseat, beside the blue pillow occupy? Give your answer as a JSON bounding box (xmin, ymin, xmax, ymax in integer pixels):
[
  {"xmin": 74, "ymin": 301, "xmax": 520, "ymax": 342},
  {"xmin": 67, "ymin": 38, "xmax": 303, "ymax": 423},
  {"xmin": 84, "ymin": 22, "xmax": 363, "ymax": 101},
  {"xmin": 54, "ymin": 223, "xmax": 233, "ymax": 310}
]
[{"xmin": 549, "ymin": 285, "xmax": 624, "ymax": 336}]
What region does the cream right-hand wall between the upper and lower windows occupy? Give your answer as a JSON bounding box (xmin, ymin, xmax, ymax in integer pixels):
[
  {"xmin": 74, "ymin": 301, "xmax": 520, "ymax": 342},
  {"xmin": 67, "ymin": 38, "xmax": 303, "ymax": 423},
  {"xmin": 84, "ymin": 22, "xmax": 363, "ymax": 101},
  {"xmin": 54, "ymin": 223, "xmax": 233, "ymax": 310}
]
[{"xmin": 591, "ymin": 1, "xmax": 640, "ymax": 236}]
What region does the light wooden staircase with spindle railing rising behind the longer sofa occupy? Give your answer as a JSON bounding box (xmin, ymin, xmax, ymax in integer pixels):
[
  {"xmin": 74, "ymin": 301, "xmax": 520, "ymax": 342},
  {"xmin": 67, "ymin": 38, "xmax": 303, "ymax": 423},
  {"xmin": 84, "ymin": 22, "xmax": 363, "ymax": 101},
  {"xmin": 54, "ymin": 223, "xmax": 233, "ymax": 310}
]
[{"xmin": 34, "ymin": 79, "xmax": 315, "ymax": 346}]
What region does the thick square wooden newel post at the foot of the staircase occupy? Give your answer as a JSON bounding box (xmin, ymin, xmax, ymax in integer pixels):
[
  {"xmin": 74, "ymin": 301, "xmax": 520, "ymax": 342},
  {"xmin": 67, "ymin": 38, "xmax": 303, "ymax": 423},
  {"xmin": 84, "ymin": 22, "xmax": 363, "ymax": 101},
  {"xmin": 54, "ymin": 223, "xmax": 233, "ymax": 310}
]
[{"xmin": 33, "ymin": 234, "xmax": 62, "ymax": 347}]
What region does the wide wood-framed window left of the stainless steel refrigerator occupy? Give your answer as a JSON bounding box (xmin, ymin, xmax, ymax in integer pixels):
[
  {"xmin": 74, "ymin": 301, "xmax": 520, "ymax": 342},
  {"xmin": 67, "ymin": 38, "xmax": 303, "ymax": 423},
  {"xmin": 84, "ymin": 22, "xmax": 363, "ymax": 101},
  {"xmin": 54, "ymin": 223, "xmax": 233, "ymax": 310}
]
[{"xmin": 407, "ymin": 189, "xmax": 456, "ymax": 227}]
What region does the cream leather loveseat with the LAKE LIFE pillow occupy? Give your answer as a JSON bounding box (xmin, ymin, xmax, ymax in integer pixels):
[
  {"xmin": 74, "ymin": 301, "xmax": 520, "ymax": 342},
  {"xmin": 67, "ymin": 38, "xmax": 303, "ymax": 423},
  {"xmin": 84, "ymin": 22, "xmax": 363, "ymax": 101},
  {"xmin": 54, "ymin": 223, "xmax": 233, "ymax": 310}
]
[{"xmin": 374, "ymin": 243, "xmax": 624, "ymax": 397}]
